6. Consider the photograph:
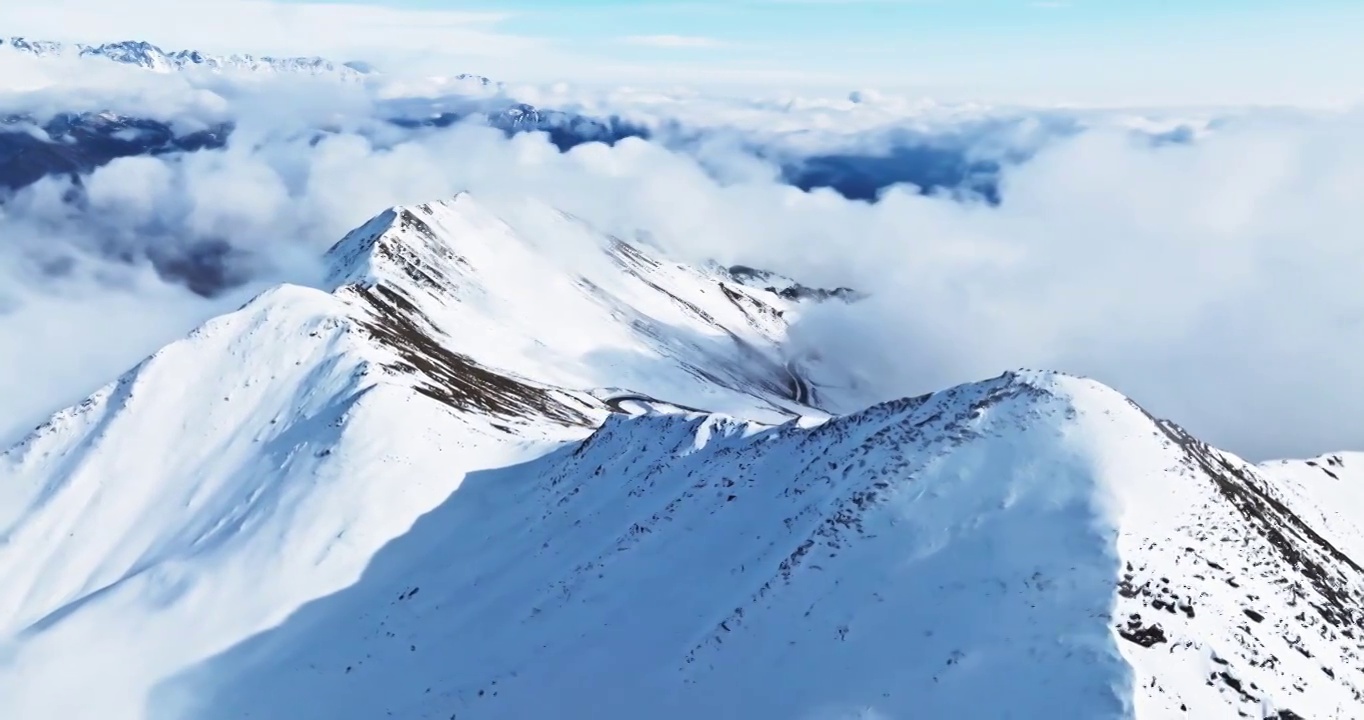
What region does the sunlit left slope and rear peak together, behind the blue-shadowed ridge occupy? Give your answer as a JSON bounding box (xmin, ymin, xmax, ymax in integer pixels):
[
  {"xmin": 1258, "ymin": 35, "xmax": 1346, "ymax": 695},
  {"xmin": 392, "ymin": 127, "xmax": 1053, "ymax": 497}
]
[{"xmin": 0, "ymin": 190, "xmax": 814, "ymax": 717}]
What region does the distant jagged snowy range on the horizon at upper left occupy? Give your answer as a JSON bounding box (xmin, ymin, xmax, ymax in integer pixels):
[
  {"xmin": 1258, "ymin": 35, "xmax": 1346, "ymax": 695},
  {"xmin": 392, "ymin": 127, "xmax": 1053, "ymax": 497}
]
[{"xmin": 0, "ymin": 37, "xmax": 370, "ymax": 80}]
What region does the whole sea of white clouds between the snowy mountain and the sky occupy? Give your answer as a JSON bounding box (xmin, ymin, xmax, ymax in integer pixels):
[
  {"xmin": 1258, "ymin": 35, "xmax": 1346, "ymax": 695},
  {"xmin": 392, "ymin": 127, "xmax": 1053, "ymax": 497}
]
[{"xmin": 0, "ymin": 46, "xmax": 1364, "ymax": 458}]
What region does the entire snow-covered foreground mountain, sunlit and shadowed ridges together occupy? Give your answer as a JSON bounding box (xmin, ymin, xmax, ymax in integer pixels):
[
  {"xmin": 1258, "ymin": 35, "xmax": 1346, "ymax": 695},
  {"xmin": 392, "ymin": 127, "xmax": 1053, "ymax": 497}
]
[{"xmin": 0, "ymin": 195, "xmax": 1364, "ymax": 720}]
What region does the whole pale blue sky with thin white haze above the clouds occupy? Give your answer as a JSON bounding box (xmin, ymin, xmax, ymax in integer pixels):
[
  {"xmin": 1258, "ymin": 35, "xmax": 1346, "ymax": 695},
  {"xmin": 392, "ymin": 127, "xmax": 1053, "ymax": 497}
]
[{"xmin": 0, "ymin": 0, "xmax": 1364, "ymax": 105}]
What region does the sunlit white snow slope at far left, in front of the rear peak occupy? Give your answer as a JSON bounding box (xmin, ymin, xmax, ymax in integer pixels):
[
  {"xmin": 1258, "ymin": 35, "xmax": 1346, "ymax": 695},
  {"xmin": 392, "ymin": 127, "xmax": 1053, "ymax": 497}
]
[{"xmin": 0, "ymin": 288, "xmax": 586, "ymax": 717}]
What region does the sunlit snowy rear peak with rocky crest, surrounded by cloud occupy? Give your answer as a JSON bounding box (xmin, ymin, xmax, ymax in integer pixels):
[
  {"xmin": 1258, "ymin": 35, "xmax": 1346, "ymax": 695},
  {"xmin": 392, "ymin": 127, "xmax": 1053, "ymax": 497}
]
[{"xmin": 319, "ymin": 192, "xmax": 817, "ymax": 421}]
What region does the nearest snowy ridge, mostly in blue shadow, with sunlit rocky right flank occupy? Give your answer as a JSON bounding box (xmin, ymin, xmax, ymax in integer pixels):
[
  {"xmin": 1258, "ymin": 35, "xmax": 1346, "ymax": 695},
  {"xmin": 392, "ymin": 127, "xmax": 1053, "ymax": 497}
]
[{"xmin": 154, "ymin": 374, "xmax": 1364, "ymax": 719}]
